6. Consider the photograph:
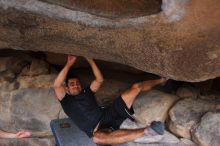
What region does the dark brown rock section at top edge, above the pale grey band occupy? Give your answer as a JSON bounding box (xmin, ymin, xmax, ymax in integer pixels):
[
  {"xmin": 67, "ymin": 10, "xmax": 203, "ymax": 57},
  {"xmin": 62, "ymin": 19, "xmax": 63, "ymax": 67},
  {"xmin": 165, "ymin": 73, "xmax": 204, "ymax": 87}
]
[{"xmin": 41, "ymin": 0, "xmax": 162, "ymax": 18}]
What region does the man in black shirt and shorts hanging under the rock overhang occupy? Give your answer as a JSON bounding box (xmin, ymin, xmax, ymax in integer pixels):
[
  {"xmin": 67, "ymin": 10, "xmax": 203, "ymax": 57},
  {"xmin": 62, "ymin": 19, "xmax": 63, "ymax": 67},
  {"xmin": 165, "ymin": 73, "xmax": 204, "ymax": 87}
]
[{"xmin": 54, "ymin": 55, "xmax": 166, "ymax": 145}]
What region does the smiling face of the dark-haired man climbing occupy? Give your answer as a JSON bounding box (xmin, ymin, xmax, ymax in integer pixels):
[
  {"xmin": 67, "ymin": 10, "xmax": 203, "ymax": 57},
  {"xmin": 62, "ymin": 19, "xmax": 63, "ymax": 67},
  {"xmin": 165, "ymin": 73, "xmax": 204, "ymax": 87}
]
[{"xmin": 67, "ymin": 78, "xmax": 82, "ymax": 95}]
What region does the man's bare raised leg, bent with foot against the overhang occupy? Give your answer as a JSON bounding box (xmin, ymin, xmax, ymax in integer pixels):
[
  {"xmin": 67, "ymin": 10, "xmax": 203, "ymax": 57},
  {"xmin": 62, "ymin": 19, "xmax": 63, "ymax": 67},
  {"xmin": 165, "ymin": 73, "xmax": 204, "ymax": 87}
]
[{"xmin": 121, "ymin": 78, "xmax": 166, "ymax": 108}]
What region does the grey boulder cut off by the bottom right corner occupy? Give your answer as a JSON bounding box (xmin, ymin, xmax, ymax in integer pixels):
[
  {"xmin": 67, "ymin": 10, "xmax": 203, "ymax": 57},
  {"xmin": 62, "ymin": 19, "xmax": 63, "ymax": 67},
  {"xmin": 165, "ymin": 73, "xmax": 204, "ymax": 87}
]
[{"xmin": 192, "ymin": 112, "xmax": 220, "ymax": 146}]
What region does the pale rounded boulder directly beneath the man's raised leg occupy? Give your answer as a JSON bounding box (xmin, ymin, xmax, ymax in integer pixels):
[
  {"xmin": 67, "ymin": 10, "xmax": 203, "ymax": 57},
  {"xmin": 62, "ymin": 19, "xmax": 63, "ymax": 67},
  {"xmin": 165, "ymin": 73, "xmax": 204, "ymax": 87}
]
[{"xmin": 133, "ymin": 91, "xmax": 179, "ymax": 124}]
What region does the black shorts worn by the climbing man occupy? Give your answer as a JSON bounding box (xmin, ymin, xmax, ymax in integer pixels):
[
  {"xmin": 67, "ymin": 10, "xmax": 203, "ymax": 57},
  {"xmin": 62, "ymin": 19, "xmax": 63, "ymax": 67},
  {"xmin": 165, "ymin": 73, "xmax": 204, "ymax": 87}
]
[{"xmin": 99, "ymin": 97, "xmax": 134, "ymax": 130}]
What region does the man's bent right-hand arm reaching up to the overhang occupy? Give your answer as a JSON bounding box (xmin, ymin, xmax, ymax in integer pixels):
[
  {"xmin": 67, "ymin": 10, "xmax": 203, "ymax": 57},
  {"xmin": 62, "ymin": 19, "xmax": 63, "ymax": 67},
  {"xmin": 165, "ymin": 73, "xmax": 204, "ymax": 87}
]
[{"xmin": 86, "ymin": 58, "xmax": 104, "ymax": 92}]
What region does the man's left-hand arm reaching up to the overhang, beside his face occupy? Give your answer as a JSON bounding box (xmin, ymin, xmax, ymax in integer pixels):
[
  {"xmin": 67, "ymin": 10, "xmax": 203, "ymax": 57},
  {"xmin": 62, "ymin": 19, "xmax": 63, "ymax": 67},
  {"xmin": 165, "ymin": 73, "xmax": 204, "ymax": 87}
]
[{"xmin": 53, "ymin": 55, "xmax": 76, "ymax": 100}]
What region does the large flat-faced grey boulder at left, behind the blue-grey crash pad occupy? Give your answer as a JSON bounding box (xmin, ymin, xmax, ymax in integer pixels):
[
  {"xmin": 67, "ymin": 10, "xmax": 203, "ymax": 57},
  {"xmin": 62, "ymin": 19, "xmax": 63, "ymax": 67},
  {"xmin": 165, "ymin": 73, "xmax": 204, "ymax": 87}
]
[{"xmin": 0, "ymin": 89, "xmax": 61, "ymax": 132}]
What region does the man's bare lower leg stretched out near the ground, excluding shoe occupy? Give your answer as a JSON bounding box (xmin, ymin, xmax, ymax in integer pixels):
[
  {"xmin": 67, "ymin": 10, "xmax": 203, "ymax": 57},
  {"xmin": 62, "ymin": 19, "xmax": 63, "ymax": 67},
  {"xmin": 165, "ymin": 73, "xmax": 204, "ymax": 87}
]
[{"xmin": 92, "ymin": 128, "xmax": 145, "ymax": 145}]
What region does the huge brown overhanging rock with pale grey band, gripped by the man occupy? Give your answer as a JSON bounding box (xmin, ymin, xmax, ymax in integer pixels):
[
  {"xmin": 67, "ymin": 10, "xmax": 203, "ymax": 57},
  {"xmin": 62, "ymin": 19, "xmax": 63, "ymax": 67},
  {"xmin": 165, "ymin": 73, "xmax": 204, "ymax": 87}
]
[{"xmin": 0, "ymin": 0, "xmax": 220, "ymax": 81}]
